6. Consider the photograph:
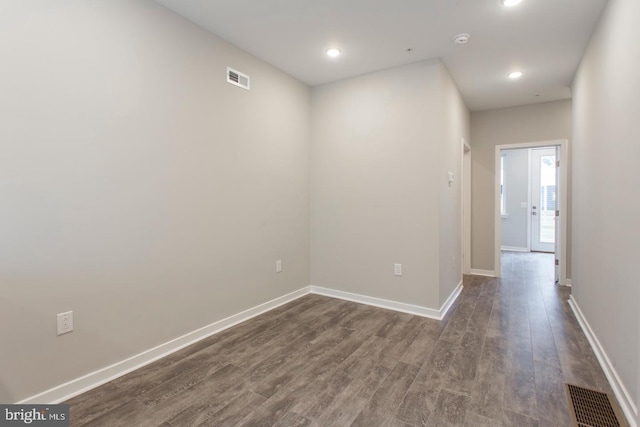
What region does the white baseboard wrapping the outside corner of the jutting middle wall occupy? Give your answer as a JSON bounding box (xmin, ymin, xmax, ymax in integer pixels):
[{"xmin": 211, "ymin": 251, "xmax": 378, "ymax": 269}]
[{"xmin": 311, "ymin": 281, "xmax": 462, "ymax": 320}]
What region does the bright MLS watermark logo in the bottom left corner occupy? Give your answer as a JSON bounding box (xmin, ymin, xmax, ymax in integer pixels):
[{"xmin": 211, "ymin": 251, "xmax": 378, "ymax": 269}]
[{"xmin": 0, "ymin": 405, "xmax": 70, "ymax": 427}]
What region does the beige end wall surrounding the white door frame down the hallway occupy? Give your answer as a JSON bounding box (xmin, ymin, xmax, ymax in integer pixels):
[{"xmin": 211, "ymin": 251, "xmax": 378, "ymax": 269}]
[{"xmin": 471, "ymin": 100, "xmax": 572, "ymax": 278}]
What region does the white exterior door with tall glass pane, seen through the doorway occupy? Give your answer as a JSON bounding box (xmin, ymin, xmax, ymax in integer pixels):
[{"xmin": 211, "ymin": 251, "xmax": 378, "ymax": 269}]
[{"xmin": 531, "ymin": 148, "xmax": 558, "ymax": 252}]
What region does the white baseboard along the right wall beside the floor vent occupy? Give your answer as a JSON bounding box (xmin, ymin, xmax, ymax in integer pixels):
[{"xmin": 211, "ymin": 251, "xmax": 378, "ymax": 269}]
[{"xmin": 569, "ymin": 295, "xmax": 638, "ymax": 427}]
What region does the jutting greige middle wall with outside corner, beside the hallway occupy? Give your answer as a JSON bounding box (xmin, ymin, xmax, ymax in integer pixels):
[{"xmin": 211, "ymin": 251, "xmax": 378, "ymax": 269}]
[{"xmin": 311, "ymin": 61, "xmax": 468, "ymax": 309}]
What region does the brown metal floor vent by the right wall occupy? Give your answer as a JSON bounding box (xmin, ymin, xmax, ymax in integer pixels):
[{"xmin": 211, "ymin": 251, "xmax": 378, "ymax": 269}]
[{"xmin": 565, "ymin": 384, "xmax": 627, "ymax": 427}]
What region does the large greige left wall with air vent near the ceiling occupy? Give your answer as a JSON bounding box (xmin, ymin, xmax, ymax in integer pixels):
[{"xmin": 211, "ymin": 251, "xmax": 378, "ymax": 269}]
[{"xmin": 0, "ymin": 0, "xmax": 310, "ymax": 402}]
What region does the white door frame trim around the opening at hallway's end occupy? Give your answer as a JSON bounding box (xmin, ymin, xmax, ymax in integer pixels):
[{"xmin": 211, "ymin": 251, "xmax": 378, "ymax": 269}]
[{"xmin": 493, "ymin": 139, "xmax": 569, "ymax": 285}]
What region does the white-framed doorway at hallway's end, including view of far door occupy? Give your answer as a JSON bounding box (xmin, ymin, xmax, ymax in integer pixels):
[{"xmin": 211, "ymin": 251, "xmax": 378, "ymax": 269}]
[{"xmin": 494, "ymin": 140, "xmax": 567, "ymax": 285}]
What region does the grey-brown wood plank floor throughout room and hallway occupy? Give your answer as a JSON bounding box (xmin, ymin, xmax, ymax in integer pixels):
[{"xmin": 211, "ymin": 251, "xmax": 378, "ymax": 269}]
[{"xmin": 67, "ymin": 253, "xmax": 611, "ymax": 427}]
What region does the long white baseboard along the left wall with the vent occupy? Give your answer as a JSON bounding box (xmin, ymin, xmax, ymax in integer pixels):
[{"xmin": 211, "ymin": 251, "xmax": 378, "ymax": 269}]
[{"xmin": 17, "ymin": 286, "xmax": 310, "ymax": 404}]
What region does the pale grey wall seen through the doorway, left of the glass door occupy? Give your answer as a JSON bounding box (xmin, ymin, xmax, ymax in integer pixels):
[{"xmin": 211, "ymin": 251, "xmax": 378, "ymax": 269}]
[{"xmin": 500, "ymin": 148, "xmax": 529, "ymax": 249}]
